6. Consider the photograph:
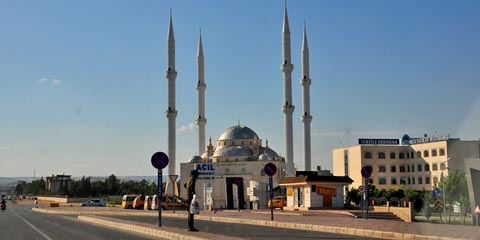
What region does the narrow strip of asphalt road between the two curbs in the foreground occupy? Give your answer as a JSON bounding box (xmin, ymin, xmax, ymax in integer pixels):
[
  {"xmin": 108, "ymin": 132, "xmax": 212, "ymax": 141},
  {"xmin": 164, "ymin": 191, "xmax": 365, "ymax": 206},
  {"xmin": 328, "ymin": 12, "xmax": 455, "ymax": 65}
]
[{"xmin": 109, "ymin": 216, "xmax": 373, "ymax": 240}]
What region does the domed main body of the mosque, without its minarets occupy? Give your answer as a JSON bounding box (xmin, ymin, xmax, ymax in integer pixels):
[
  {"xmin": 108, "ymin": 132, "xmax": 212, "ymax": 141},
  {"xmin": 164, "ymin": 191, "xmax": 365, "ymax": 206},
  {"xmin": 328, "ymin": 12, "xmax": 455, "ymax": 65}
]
[{"xmin": 179, "ymin": 125, "xmax": 285, "ymax": 209}]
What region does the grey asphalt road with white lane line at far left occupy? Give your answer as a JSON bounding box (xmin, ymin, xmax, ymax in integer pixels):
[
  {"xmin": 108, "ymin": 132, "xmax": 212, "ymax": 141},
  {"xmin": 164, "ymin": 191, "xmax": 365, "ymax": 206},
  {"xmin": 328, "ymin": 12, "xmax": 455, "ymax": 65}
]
[{"xmin": 0, "ymin": 201, "xmax": 158, "ymax": 240}]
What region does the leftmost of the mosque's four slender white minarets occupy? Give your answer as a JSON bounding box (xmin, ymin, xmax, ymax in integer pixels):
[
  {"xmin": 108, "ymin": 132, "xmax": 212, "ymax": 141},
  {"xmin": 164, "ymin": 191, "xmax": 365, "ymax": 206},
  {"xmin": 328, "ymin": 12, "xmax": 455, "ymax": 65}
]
[{"xmin": 165, "ymin": 11, "xmax": 177, "ymax": 175}]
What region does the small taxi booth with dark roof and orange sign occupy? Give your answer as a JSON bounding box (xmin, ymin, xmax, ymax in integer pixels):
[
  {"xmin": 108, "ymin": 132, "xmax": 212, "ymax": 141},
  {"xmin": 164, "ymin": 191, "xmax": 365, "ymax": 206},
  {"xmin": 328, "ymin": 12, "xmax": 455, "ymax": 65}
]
[{"xmin": 279, "ymin": 171, "xmax": 353, "ymax": 210}]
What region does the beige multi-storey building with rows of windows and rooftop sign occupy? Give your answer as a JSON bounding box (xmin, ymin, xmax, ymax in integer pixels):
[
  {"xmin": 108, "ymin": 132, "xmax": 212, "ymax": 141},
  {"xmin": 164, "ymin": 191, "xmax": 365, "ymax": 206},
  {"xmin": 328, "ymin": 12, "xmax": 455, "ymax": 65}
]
[{"xmin": 333, "ymin": 135, "xmax": 480, "ymax": 190}]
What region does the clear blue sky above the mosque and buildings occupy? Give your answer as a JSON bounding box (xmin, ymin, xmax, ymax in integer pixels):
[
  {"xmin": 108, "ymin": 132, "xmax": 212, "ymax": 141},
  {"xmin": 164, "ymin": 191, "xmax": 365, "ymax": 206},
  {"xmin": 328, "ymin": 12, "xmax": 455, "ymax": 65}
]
[{"xmin": 0, "ymin": 0, "xmax": 480, "ymax": 177}]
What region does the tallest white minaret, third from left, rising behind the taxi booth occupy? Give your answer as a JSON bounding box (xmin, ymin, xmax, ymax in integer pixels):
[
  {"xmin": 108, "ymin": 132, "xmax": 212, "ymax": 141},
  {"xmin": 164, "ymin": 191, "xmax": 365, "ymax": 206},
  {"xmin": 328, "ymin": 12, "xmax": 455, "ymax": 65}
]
[{"xmin": 280, "ymin": 1, "xmax": 295, "ymax": 176}]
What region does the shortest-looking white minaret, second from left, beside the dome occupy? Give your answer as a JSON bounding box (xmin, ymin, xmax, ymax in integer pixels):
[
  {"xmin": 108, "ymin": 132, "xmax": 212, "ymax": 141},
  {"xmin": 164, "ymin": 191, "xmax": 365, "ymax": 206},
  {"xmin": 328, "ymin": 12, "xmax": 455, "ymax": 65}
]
[{"xmin": 197, "ymin": 32, "xmax": 207, "ymax": 156}]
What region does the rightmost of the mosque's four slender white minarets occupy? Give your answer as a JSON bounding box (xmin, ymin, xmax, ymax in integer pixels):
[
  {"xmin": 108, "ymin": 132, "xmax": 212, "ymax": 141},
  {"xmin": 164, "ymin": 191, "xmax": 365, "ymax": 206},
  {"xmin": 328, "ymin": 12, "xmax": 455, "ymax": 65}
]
[{"xmin": 300, "ymin": 24, "xmax": 312, "ymax": 171}]
